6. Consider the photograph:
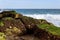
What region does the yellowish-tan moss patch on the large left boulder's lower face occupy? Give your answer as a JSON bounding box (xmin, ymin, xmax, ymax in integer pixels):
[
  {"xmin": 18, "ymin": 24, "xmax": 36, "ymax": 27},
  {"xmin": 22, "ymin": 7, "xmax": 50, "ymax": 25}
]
[{"xmin": 5, "ymin": 27, "xmax": 22, "ymax": 35}]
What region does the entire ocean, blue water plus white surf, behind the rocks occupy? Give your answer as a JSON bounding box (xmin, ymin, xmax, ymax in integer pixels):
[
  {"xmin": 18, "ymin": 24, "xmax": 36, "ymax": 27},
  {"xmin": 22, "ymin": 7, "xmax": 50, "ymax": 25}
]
[{"xmin": 0, "ymin": 9, "xmax": 60, "ymax": 27}]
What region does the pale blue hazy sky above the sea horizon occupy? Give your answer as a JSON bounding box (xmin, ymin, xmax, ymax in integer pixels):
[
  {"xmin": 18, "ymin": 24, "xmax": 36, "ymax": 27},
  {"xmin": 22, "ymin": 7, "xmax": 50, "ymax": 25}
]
[{"xmin": 0, "ymin": 0, "xmax": 60, "ymax": 9}]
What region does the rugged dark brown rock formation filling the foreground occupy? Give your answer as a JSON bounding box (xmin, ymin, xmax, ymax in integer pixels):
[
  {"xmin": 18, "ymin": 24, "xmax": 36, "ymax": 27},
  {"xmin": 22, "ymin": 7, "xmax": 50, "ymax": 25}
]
[{"xmin": 0, "ymin": 11, "xmax": 60, "ymax": 40}]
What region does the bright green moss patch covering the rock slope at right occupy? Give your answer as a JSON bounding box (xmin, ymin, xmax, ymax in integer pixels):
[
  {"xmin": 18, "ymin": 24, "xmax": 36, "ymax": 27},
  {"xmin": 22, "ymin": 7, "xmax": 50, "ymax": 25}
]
[{"xmin": 37, "ymin": 24, "xmax": 60, "ymax": 35}]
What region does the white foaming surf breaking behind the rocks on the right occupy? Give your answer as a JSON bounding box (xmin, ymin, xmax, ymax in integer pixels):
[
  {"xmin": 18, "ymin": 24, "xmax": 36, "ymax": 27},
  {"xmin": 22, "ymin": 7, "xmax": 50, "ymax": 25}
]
[{"xmin": 24, "ymin": 14, "xmax": 60, "ymax": 27}]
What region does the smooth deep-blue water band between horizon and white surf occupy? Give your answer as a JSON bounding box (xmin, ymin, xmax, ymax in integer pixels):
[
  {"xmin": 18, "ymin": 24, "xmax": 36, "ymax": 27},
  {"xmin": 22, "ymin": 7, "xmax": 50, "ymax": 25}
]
[{"xmin": 15, "ymin": 9, "xmax": 60, "ymax": 14}]
